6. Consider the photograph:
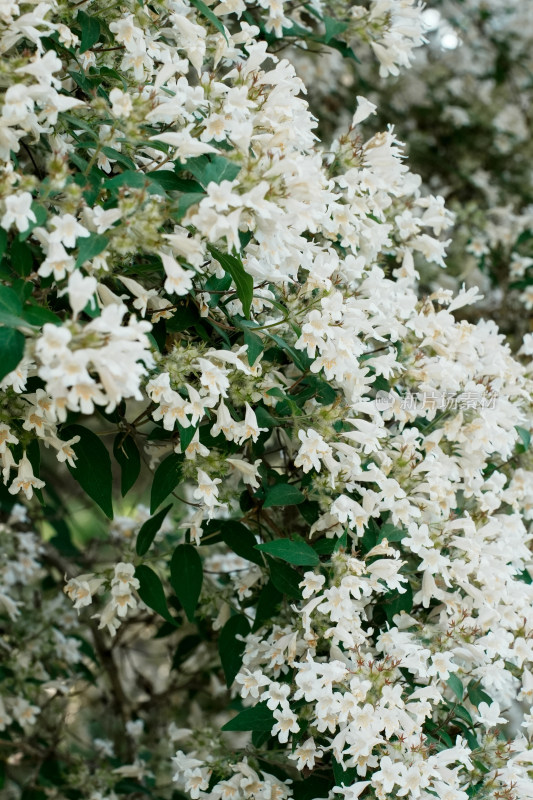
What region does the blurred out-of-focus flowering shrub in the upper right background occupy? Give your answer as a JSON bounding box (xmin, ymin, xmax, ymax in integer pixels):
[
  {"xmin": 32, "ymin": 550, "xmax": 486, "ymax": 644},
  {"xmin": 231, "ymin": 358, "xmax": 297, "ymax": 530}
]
[{"xmin": 291, "ymin": 0, "xmax": 533, "ymax": 336}]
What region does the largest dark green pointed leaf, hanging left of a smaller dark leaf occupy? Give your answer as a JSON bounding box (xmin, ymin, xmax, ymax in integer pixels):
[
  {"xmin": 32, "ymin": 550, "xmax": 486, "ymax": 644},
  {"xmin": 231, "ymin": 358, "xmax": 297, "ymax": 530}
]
[{"xmin": 61, "ymin": 425, "xmax": 113, "ymax": 519}]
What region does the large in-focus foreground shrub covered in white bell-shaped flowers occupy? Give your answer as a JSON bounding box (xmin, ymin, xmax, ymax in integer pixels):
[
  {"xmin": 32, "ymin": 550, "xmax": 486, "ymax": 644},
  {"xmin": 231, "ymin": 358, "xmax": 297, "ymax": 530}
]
[{"xmin": 0, "ymin": 0, "xmax": 533, "ymax": 800}]
